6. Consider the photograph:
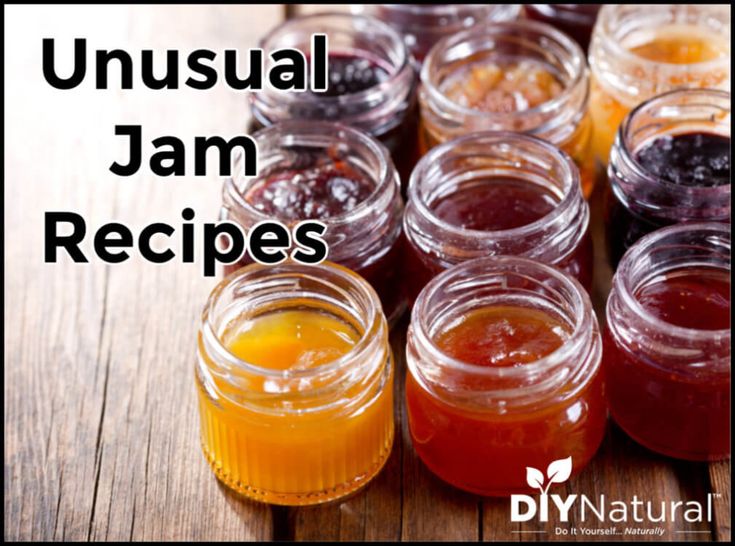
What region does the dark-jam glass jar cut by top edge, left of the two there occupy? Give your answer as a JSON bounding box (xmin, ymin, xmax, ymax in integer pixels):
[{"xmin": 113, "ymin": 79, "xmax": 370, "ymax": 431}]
[{"xmin": 352, "ymin": 4, "xmax": 520, "ymax": 64}]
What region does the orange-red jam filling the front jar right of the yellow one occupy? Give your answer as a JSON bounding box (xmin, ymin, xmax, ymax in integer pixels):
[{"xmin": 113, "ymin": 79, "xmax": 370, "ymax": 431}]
[{"xmin": 406, "ymin": 305, "xmax": 605, "ymax": 495}]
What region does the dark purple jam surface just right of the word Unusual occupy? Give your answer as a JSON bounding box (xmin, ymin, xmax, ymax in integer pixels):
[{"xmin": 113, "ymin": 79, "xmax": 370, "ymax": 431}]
[{"xmin": 315, "ymin": 53, "xmax": 390, "ymax": 97}]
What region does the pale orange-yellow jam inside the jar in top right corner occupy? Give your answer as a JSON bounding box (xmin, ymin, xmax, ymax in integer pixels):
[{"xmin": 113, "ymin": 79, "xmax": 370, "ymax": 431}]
[{"xmin": 590, "ymin": 25, "xmax": 730, "ymax": 164}]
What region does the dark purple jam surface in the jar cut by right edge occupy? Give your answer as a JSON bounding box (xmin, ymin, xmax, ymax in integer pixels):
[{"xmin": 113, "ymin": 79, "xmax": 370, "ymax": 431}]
[{"xmin": 636, "ymin": 133, "xmax": 730, "ymax": 186}]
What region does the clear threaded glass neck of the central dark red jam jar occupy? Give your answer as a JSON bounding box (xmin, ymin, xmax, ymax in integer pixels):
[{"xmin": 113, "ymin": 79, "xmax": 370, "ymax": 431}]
[{"xmin": 404, "ymin": 132, "xmax": 589, "ymax": 266}]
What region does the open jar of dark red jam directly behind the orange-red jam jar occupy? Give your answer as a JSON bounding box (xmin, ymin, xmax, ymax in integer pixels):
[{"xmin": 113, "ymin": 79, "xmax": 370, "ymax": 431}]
[{"xmin": 403, "ymin": 132, "xmax": 593, "ymax": 299}]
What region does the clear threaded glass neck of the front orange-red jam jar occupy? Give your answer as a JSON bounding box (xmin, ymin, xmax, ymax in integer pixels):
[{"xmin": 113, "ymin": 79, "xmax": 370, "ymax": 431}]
[{"xmin": 407, "ymin": 256, "xmax": 601, "ymax": 413}]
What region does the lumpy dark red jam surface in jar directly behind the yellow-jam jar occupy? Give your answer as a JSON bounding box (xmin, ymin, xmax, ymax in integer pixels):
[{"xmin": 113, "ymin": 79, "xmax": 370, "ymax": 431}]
[{"xmin": 245, "ymin": 152, "xmax": 375, "ymax": 221}]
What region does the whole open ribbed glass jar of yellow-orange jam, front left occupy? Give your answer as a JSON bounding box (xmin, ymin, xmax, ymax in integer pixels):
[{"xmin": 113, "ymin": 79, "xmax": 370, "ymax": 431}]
[{"xmin": 196, "ymin": 262, "xmax": 394, "ymax": 505}]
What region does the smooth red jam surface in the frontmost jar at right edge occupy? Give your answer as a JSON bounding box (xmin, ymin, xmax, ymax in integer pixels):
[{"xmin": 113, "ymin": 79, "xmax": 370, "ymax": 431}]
[{"xmin": 635, "ymin": 271, "xmax": 730, "ymax": 330}]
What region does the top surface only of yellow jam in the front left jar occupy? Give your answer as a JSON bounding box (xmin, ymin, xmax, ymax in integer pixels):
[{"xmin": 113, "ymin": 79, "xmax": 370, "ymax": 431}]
[{"xmin": 227, "ymin": 310, "xmax": 360, "ymax": 370}]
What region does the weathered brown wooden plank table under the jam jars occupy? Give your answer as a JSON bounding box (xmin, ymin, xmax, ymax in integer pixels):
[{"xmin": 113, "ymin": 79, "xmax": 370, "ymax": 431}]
[{"xmin": 5, "ymin": 5, "xmax": 730, "ymax": 541}]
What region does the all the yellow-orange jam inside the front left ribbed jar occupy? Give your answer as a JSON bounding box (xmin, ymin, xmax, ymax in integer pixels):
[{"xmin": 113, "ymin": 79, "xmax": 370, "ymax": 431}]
[{"xmin": 198, "ymin": 308, "xmax": 393, "ymax": 505}]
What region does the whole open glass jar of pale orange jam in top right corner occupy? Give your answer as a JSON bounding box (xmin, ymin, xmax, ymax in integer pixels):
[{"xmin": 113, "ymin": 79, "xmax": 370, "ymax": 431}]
[{"xmin": 589, "ymin": 4, "xmax": 730, "ymax": 164}]
